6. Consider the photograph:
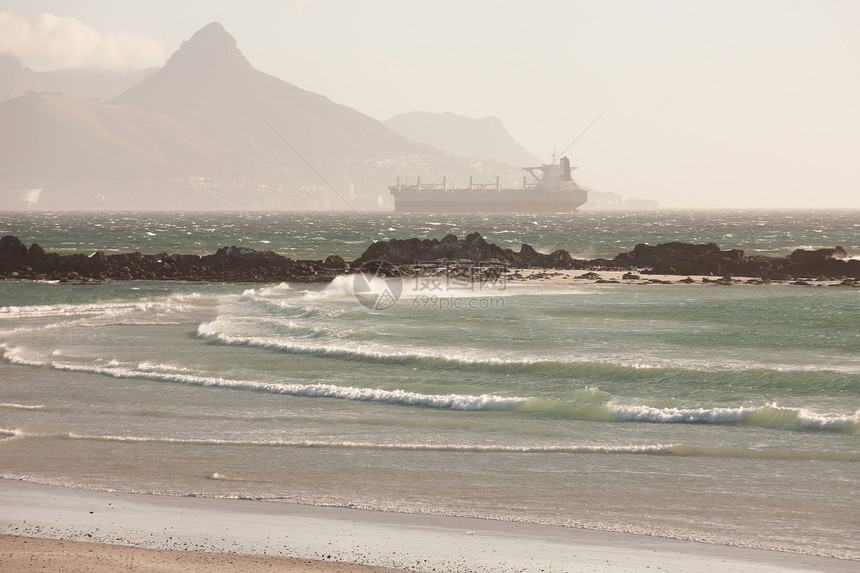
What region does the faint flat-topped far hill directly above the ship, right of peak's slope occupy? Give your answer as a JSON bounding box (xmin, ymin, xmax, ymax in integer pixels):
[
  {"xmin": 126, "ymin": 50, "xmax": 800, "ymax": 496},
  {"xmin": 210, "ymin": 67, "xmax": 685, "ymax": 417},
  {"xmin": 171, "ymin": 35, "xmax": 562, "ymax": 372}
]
[{"xmin": 383, "ymin": 111, "xmax": 543, "ymax": 167}]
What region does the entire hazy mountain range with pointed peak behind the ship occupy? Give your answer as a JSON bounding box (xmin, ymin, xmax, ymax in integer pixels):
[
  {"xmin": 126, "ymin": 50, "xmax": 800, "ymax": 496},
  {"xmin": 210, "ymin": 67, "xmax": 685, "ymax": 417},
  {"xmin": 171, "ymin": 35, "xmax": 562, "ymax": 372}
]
[{"xmin": 0, "ymin": 23, "xmax": 660, "ymax": 210}]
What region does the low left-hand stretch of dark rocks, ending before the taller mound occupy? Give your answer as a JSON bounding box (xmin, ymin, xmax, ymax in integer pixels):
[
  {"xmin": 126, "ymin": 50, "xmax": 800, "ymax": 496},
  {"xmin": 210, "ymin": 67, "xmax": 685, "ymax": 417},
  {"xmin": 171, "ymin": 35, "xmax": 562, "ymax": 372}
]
[{"xmin": 0, "ymin": 235, "xmax": 349, "ymax": 282}]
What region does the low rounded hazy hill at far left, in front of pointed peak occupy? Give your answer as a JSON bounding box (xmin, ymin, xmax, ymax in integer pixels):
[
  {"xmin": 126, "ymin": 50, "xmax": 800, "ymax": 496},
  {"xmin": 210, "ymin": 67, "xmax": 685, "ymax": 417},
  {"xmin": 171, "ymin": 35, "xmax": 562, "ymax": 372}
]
[{"xmin": 0, "ymin": 95, "xmax": 226, "ymax": 179}]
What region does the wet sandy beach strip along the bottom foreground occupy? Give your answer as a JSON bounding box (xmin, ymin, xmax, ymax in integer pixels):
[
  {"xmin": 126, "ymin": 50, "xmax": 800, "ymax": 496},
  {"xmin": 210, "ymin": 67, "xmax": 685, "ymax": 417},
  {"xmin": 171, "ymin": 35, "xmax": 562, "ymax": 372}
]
[{"xmin": 0, "ymin": 479, "xmax": 857, "ymax": 573}]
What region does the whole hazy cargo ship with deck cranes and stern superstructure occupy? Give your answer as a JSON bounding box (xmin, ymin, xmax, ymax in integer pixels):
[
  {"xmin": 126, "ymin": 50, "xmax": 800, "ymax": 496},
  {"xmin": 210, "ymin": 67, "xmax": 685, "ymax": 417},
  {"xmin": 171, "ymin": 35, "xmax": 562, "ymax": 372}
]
[{"xmin": 388, "ymin": 157, "xmax": 588, "ymax": 213}]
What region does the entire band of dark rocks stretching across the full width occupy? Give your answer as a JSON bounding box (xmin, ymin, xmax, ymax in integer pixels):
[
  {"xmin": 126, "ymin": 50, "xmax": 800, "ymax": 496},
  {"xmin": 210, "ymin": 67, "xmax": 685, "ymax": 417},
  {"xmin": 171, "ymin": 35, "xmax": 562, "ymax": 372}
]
[{"xmin": 0, "ymin": 233, "xmax": 860, "ymax": 286}]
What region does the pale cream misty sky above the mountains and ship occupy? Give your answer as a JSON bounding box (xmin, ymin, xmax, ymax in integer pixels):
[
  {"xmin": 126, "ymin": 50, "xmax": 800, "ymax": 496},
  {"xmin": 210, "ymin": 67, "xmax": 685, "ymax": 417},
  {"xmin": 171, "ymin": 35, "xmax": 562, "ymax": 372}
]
[{"xmin": 0, "ymin": 0, "xmax": 860, "ymax": 208}]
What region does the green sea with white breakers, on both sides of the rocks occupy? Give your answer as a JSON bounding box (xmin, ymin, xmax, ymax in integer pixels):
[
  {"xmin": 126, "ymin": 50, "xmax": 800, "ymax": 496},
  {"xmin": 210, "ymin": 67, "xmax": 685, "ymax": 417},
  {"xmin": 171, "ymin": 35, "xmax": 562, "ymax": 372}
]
[{"xmin": 0, "ymin": 210, "xmax": 860, "ymax": 560}]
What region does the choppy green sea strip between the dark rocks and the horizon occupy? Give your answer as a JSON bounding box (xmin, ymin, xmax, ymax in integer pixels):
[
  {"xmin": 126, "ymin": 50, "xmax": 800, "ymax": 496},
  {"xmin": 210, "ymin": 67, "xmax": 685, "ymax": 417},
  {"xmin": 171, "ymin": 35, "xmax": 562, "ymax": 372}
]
[{"xmin": 6, "ymin": 210, "xmax": 860, "ymax": 260}]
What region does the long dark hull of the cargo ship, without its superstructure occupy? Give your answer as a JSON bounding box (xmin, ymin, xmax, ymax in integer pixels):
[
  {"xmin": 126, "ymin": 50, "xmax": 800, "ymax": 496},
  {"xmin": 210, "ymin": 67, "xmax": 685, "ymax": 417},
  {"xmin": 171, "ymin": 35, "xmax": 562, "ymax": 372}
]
[{"xmin": 391, "ymin": 189, "xmax": 588, "ymax": 213}]
